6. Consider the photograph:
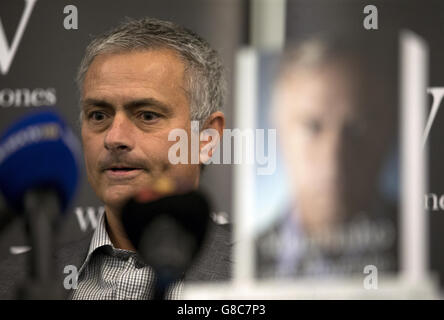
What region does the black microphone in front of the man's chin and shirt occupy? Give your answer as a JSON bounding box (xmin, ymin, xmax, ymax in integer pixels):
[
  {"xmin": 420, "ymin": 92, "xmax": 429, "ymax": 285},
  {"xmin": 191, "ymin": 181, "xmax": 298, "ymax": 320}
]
[{"xmin": 122, "ymin": 186, "xmax": 210, "ymax": 300}]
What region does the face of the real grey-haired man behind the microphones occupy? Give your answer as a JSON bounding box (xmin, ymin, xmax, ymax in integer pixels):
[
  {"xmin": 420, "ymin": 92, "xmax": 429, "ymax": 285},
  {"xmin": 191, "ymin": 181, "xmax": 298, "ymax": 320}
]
[{"xmin": 82, "ymin": 49, "xmax": 199, "ymax": 208}]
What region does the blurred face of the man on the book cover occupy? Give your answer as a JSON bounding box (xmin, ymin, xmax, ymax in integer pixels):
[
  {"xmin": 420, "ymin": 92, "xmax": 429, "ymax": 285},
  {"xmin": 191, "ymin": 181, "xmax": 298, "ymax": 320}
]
[{"xmin": 276, "ymin": 63, "xmax": 394, "ymax": 232}]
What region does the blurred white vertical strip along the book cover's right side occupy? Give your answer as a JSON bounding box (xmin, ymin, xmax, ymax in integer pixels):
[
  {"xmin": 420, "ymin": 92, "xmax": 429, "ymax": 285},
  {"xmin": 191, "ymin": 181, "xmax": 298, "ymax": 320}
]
[{"xmin": 400, "ymin": 31, "xmax": 428, "ymax": 283}]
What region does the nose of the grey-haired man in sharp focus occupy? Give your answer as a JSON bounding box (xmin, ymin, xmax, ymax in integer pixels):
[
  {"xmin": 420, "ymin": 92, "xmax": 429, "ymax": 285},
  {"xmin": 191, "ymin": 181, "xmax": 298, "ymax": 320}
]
[{"xmin": 104, "ymin": 112, "xmax": 134, "ymax": 151}]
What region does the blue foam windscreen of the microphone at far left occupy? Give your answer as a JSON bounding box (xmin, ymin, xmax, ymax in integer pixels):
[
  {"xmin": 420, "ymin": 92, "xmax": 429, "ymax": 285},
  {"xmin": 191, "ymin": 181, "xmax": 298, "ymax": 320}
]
[{"xmin": 0, "ymin": 110, "xmax": 81, "ymax": 211}]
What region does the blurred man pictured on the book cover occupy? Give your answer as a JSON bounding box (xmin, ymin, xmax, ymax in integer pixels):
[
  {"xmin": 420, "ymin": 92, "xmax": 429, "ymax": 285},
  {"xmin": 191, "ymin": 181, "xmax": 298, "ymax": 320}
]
[{"xmin": 257, "ymin": 36, "xmax": 398, "ymax": 277}]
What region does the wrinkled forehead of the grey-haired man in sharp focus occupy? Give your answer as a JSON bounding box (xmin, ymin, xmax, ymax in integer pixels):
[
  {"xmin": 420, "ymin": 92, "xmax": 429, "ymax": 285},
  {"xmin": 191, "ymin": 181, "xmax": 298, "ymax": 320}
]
[{"xmin": 82, "ymin": 49, "xmax": 188, "ymax": 103}]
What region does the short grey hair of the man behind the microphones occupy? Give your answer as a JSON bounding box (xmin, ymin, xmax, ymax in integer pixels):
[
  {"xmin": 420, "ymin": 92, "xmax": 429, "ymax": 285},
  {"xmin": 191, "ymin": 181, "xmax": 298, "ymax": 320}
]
[{"xmin": 76, "ymin": 18, "xmax": 226, "ymax": 125}]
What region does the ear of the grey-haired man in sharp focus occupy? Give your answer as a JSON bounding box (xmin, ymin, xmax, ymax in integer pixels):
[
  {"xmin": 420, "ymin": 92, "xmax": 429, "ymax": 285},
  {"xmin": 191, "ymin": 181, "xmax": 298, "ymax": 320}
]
[{"xmin": 199, "ymin": 111, "xmax": 225, "ymax": 164}]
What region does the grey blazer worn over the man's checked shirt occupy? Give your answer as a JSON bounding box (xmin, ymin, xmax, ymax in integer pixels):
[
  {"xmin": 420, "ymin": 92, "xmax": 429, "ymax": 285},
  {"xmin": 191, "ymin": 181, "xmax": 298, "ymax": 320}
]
[{"xmin": 0, "ymin": 223, "xmax": 232, "ymax": 299}]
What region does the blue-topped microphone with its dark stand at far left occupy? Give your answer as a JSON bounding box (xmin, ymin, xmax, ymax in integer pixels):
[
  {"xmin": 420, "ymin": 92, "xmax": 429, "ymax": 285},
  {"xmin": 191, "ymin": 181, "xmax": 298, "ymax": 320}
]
[{"xmin": 0, "ymin": 110, "xmax": 81, "ymax": 299}]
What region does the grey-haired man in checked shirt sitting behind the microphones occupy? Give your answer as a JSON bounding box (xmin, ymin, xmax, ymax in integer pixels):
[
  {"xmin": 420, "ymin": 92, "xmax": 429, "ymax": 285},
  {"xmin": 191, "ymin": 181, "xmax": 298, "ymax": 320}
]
[{"xmin": 0, "ymin": 18, "xmax": 230, "ymax": 299}]
